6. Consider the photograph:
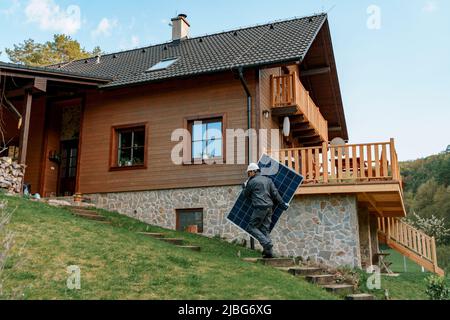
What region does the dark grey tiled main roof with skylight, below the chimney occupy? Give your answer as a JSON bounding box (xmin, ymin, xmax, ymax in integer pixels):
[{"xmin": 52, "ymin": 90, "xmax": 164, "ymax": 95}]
[{"xmin": 51, "ymin": 14, "xmax": 327, "ymax": 87}]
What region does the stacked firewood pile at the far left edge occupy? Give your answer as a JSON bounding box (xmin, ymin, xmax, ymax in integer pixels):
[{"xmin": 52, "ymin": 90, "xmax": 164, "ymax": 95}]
[{"xmin": 0, "ymin": 158, "xmax": 25, "ymax": 193}]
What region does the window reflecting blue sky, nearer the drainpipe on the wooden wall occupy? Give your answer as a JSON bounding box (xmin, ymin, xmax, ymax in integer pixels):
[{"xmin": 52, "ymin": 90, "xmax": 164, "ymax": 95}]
[{"xmin": 189, "ymin": 118, "xmax": 224, "ymax": 162}]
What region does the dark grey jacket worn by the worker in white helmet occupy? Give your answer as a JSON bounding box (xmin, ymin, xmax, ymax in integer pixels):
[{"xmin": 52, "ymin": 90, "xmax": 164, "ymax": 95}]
[{"xmin": 244, "ymin": 174, "xmax": 284, "ymax": 209}]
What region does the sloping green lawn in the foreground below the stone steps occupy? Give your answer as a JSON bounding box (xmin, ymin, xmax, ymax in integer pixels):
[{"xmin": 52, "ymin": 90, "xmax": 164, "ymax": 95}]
[{"xmin": 0, "ymin": 195, "xmax": 336, "ymax": 300}]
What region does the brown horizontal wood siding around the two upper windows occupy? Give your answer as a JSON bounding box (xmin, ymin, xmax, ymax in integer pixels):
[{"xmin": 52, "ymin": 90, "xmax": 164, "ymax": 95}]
[{"xmin": 79, "ymin": 72, "xmax": 256, "ymax": 194}]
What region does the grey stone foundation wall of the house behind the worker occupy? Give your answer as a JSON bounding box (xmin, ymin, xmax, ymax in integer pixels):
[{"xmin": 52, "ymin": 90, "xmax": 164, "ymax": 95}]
[{"xmin": 89, "ymin": 186, "xmax": 361, "ymax": 267}]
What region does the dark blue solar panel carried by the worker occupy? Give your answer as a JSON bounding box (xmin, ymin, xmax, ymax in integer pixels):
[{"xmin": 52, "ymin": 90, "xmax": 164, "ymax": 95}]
[{"xmin": 227, "ymin": 155, "xmax": 303, "ymax": 232}]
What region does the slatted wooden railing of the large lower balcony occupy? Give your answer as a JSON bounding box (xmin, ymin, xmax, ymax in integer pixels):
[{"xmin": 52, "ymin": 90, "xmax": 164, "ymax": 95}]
[{"xmin": 270, "ymin": 139, "xmax": 401, "ymax": 185}]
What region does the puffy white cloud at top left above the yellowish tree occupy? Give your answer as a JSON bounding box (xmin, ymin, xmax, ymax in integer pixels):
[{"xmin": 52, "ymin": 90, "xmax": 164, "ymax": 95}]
[{"xmin": 25, "ymin": 0, "xmax": 81, "ymax": 34}]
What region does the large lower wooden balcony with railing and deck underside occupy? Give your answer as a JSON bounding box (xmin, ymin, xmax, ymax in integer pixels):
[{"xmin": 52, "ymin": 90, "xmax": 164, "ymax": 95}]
[{"xmin": 270, "ymin": 139, "xmax": 406, "ymax": 217}]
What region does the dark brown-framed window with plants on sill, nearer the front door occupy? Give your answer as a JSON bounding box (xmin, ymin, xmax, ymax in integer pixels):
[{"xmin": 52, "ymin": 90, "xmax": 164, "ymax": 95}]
[{"xmin": 111, "ymin": 125, "xmax": 147, "ymax": 169}]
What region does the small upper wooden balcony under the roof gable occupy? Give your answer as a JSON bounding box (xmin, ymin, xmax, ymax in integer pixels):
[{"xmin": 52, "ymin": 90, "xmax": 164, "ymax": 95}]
[{"xmin": 270, "ymin": 72, "xmax": 328, "ymax": 142}]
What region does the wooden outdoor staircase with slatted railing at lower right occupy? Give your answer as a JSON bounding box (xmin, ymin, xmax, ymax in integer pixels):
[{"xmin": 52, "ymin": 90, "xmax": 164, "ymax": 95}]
[{"xmin": 378, "ymin": 217, "xmax": 445, "ymax": 276}]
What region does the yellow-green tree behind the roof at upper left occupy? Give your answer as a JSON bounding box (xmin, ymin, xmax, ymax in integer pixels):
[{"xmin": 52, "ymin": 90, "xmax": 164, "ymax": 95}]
[{"xmin": 6, "ymin": 34, "xmax": 102, "ymax": 66}]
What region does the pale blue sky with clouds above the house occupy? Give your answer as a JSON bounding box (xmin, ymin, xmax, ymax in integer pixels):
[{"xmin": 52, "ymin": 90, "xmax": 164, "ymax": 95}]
[{"xmin": 0, "ymin": 0, "xmax": 450, "ymax": 160}]
